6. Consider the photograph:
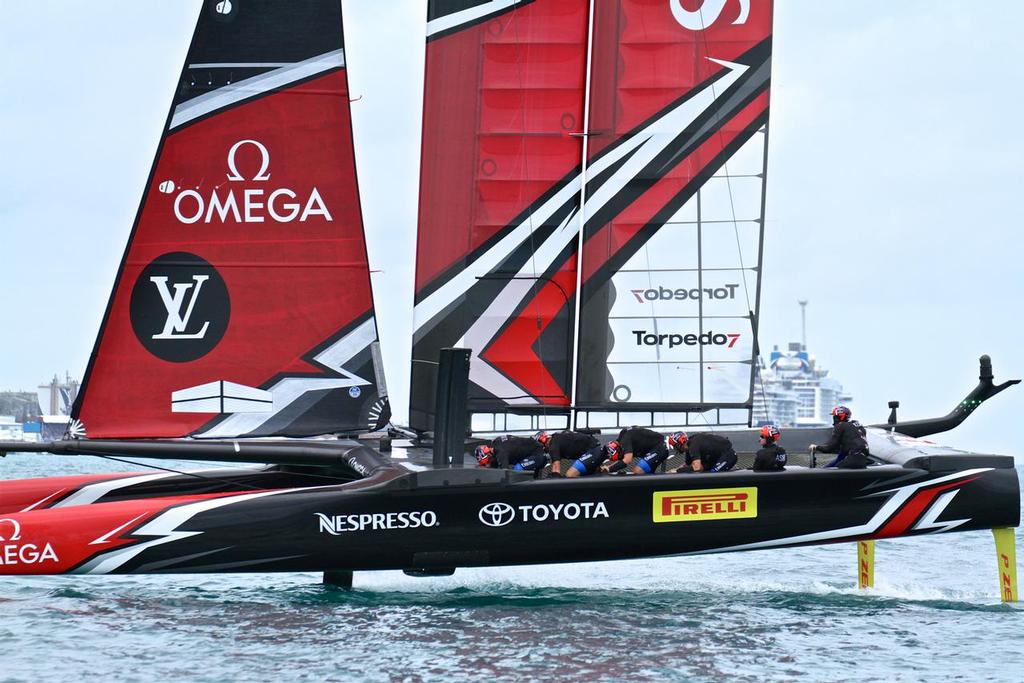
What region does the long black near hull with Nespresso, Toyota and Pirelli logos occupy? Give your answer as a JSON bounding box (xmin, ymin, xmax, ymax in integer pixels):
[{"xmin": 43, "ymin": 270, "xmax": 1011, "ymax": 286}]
[{"xmin": 0, "ymin": 458, "xmax": 1007, "ymax": 573}]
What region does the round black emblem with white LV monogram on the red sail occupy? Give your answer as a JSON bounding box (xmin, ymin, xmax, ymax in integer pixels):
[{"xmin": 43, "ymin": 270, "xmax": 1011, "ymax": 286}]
[{"xmin": 130, "ymin": 252, "xmax": 231, "ymax": 362}]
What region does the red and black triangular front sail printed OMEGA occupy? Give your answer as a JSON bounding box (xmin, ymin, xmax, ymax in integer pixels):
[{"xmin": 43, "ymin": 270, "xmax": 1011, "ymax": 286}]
[{"xmin": 74, "ymin": 0, "xmax": 388, "ymax": 437}]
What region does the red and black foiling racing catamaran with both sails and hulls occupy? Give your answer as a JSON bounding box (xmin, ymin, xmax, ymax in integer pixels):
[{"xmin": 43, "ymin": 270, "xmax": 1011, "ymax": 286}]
[{"xmin": 0, "ymin": 0, "xmax": 1020, "ymax": 583}]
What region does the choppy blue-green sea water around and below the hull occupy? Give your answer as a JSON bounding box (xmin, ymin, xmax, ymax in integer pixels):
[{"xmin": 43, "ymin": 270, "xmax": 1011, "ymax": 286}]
[{"xmin": 0, "ymin": 456, "xmax": 1024, "ymax": 682}]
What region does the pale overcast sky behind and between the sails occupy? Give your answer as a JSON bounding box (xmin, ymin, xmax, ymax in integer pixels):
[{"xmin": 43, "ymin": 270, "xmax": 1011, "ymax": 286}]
[{"xmin": 0, "ymin": 0, "xmax": 1024, "ymax": 455}]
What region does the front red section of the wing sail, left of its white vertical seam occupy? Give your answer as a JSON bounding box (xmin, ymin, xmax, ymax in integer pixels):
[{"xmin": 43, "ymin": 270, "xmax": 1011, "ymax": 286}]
[{"xmin": 410, "ymin": 0, "xmax": 589, "ymax": 430}]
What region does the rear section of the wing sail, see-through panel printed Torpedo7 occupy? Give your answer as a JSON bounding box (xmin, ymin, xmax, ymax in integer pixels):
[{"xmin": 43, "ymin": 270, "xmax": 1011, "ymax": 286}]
[{"xmin": 577, "ymin": 0, "xmax": 772, "ymax": 424}]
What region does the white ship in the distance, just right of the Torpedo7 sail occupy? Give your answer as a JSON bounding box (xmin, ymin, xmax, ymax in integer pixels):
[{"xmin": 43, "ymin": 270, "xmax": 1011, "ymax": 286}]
[{"xmin": 754, "ymin": 342, "xmax": 853, "ymax": 427}]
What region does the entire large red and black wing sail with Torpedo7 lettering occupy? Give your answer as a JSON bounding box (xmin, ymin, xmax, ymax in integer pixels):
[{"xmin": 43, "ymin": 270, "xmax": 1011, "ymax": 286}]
[{"xmin": 411, "ymin": 0, "xmax": 772, "ymax": 429}]
